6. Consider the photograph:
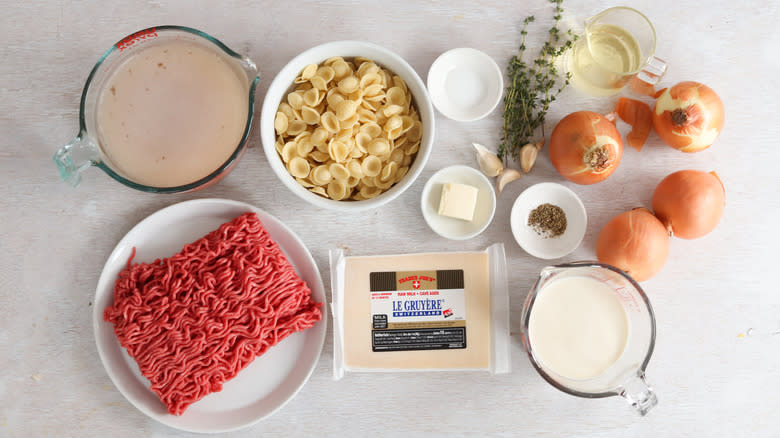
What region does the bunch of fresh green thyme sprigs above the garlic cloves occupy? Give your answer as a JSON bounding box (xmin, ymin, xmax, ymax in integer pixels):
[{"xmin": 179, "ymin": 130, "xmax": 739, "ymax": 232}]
[{"xmin": 498, "ymin": 0, "xmax": 577, "ymax": 162}]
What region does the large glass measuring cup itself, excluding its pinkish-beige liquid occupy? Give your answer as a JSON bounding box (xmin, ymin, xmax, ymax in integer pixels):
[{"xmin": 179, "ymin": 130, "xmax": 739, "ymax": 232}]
[{"xmin": 53, "ymin": 26, "xmax": 260, "ymax": 193}]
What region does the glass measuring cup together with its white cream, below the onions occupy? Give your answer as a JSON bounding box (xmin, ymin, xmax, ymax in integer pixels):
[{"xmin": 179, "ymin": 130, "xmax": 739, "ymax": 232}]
[{"xmin": 522, "ymin": 262, "xmax": 658, "ymax": 415}]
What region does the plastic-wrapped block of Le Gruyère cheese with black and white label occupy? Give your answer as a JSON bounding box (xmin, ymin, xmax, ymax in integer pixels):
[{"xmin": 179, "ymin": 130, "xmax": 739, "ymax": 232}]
[{"xmin": 330, "ymin": 243, "xmax": 510, "ymax": 380}]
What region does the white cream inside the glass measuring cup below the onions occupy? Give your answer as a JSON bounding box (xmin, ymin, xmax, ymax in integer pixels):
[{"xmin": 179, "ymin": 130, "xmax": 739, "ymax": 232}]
[{"xmin": 528, "ymin": 276, "xmax": 628, "ymax": 380}]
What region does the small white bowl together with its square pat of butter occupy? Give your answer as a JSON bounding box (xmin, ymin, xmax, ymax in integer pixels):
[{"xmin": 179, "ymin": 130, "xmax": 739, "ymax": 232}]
[{"xmin": 421, "ymin": 165, "xmax": 496, "ymax": 240}]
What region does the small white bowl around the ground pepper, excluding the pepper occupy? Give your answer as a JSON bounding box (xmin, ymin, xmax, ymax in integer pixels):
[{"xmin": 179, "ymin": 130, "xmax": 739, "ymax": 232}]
[{"xmin": 509, "ymin": 183, "xmax": 588, "ymax": 259}]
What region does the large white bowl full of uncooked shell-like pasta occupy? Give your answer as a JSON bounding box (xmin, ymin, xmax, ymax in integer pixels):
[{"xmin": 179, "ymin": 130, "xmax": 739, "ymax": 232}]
[{"xmin": 260, "ymin": 41, "xmax": 435, "ymax": 211}]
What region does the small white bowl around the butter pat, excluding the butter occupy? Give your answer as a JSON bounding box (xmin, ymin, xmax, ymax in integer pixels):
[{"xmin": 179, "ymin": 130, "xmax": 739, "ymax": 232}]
[{"xmin": 421, "ymin": 165, "xmax": 496, "ymax": 240}]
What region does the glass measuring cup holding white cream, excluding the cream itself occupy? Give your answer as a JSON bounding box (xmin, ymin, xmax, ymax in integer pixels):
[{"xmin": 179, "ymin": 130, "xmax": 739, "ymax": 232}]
[{"xmin": 522, "ymin": 262, "xmax": 658, "ymax": 415}]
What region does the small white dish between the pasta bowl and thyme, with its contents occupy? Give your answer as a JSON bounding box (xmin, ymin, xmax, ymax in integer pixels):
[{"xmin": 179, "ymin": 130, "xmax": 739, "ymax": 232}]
[{"xmin": 428, "ymin": 47, "xmax": 504, "ymax": 122}]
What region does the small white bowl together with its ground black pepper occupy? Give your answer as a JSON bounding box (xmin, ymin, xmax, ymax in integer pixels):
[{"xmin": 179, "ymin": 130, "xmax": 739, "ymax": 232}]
[{"xmin": 509, "ymin": 183, "xmax": 588, "ymax": 259}]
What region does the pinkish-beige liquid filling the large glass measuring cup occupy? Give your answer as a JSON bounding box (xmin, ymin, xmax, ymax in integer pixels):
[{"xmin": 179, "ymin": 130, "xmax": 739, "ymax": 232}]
[{"xmin": 97, "ymin": 40, "xmax": 249, "ymax": 187}]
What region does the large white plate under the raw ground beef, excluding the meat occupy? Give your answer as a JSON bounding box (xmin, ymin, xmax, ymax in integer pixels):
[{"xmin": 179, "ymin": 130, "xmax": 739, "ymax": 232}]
[{"xmin": 93, "ymin": 199, "xmax": 327, "ymax": 433}]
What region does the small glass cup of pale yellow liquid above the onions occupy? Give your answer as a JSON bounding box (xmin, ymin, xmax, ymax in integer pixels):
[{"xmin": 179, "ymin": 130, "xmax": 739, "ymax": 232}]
[{"xmin": 567, "ymin": 6, "xmax": 666, "ymax": 96}]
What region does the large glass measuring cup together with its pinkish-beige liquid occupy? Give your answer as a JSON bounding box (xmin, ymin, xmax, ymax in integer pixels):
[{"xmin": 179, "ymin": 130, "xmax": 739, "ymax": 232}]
[{"xmin": 54, "ymin": 26, "xmax": 259, "ymax": 193}]
